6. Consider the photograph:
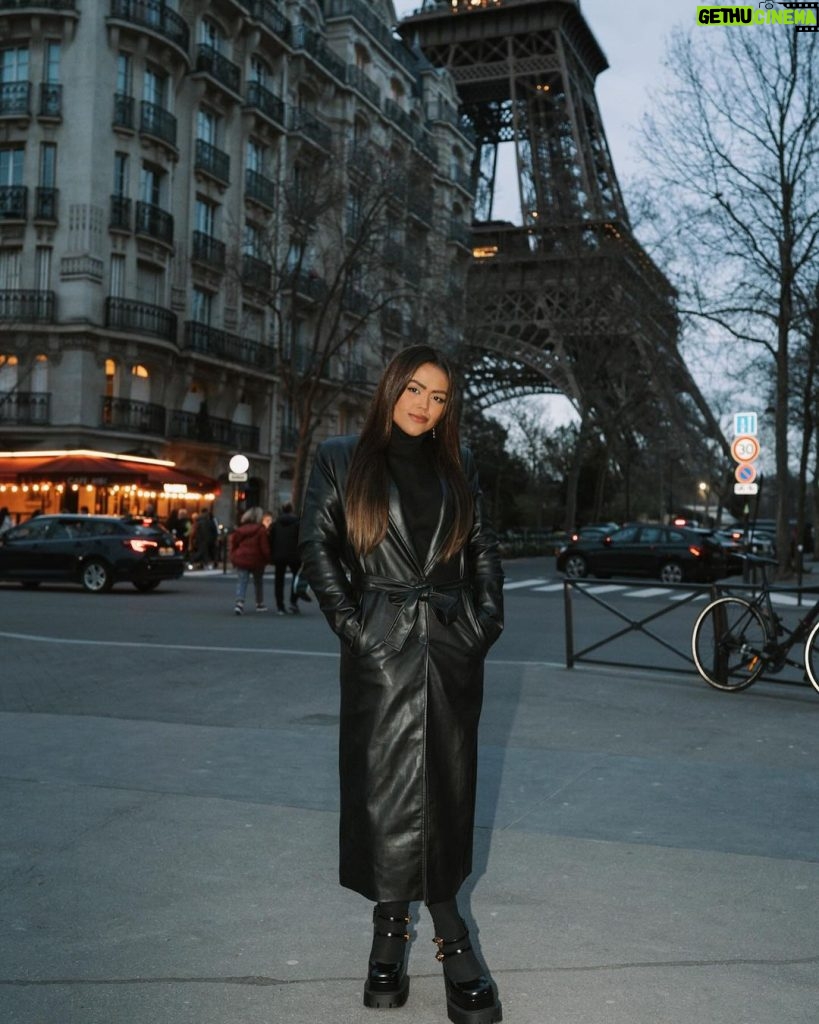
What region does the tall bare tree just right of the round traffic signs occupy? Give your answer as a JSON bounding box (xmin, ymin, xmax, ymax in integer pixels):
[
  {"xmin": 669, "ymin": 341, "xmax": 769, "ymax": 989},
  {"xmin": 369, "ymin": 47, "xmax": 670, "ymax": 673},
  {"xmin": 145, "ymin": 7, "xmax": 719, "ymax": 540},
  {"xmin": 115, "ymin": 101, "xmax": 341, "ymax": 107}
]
[{"xmin": 643, "ymin": 27, "xmax": 819, "ymax": 571}]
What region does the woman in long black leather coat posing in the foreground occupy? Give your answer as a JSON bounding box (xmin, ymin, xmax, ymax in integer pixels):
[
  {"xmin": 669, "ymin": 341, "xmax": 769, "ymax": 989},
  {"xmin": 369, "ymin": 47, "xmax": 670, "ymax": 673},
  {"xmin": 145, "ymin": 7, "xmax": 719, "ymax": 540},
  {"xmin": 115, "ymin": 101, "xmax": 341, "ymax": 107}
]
[{"xmin": 300, "ymin": 345, "xmax": 503, "ymax": 1024}]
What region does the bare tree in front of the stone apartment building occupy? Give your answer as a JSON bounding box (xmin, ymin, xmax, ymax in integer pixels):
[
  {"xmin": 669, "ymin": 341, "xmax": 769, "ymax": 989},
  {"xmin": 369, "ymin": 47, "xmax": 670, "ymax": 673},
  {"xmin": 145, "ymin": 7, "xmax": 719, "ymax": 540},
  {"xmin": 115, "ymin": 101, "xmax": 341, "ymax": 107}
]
[{"xmin": 236, "ymin": 142, "xmax": 428, "ymax": 503}]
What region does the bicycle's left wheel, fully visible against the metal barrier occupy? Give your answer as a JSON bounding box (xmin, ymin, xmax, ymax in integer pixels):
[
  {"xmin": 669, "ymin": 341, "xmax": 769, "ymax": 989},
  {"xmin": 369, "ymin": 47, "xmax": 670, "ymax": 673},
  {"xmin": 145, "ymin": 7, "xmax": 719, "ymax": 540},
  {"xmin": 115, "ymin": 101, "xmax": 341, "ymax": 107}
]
[{"xmin": 691, "ymin": 597, "xmax": 769, "ymax": 690}]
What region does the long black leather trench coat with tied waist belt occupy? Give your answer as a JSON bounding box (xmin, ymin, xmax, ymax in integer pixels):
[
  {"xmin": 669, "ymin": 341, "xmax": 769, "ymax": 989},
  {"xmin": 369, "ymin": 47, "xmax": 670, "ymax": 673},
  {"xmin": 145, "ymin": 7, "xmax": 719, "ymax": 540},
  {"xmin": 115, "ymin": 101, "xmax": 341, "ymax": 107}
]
[{"xmin": 299, "ymin": 437, "xmax": 503, "ymax": 903}]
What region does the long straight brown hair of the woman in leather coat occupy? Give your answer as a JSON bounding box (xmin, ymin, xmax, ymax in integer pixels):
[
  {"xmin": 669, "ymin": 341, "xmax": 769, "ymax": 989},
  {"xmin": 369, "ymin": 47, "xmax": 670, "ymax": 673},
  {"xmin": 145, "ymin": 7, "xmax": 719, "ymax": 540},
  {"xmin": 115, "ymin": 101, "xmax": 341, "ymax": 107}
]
[{"xmin": 345, "ymin": 345, "xmax": 473, "ymax": 561}]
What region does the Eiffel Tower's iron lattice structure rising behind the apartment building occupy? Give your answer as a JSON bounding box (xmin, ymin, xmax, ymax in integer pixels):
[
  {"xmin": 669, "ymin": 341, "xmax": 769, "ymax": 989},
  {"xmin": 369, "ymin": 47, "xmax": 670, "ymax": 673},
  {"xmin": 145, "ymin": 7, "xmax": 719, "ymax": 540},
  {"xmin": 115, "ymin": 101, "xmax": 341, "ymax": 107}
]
[{"xmin": 398, "ymin": 0, "xmax": 727, "ymax": 464}]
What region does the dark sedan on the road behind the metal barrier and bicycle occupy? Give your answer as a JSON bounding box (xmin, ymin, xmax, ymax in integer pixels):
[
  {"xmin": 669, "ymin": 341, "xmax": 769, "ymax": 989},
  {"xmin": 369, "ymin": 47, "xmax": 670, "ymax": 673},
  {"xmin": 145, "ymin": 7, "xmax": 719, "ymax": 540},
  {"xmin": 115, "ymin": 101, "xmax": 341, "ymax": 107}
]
[{"xmin": 557, "ymin": 523, "xmax": 727, "ymax": 583}]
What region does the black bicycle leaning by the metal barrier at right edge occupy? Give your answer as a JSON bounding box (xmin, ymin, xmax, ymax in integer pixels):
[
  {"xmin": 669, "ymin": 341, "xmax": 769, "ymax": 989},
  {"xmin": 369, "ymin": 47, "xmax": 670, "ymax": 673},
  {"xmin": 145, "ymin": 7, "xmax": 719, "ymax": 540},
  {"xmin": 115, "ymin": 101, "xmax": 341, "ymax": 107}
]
[{"xmin": 691, "ymin": 555, "xmax": 819, "ymax": 693}]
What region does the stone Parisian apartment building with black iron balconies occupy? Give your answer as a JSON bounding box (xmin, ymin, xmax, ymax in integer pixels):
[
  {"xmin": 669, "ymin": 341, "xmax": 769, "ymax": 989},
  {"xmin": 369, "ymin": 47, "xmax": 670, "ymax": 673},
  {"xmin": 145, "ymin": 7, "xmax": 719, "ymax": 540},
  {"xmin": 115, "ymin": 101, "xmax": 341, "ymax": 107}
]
[{"xmin": 0, "ymin": 0, "xmax": 474, "ymax": 511}]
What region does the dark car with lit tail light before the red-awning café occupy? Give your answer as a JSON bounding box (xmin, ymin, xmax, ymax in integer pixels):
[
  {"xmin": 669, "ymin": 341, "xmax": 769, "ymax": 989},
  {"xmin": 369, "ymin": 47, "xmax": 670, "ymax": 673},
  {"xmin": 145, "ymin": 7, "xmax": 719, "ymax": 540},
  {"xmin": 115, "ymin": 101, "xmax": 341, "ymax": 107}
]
[{"xmin": 0, "ymin": 514, "xmax": 185, "ymax": 594}]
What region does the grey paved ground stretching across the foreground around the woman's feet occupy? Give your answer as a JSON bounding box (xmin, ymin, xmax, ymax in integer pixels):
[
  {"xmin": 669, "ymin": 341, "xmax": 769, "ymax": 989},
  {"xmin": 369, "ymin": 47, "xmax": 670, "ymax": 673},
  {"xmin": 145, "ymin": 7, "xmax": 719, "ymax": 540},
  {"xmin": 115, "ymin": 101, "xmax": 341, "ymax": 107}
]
[{"xmin": 0, "ymin": 605, "xmax": 819, "ymax": 1024}]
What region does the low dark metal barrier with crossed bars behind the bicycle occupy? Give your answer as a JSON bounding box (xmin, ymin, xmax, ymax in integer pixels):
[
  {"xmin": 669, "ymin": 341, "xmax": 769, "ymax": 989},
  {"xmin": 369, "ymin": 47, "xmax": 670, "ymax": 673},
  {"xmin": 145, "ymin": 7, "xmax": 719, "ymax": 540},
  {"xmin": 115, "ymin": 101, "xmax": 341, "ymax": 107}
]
[{"xmin": 563, "ymin": 580, "xmax": 817, "ymax": 686}]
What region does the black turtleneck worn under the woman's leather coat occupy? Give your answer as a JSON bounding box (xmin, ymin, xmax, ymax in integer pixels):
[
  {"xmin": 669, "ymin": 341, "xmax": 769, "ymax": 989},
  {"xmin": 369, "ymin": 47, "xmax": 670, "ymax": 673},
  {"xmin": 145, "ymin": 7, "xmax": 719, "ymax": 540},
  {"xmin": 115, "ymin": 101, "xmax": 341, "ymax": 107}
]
[{"xmin": 387, "ymin": 423, "xmax": 442, "ymax": 564}]
